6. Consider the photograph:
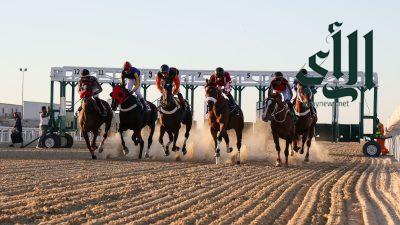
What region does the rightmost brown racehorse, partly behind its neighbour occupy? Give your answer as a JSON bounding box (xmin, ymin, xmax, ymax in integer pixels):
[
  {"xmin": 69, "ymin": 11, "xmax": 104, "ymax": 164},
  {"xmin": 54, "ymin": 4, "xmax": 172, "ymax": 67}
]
[{"xmin": 293, "ymin": 85, "xmax": 318, "ymax": 162}]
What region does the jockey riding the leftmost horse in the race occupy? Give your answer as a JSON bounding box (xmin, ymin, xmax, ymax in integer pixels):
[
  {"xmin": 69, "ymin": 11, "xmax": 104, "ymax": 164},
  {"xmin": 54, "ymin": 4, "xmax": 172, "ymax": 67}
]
[{"xmin": 78, "ymin": 69, "xmax": 107, "ymax": 117}]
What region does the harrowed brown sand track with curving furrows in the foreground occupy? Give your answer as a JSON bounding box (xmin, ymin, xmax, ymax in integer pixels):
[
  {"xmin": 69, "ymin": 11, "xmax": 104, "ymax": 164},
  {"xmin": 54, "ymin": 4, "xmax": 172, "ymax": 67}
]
[{"xmin": 0, "ymin": 143, "xmax": 400, "ymax": 224}]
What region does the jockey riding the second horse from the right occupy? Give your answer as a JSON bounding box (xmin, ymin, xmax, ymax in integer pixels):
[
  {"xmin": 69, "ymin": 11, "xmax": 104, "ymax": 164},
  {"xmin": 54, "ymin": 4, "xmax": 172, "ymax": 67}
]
[{"xmin": 268, "ymin": 71, "xmax": 295, "ymax": 115}]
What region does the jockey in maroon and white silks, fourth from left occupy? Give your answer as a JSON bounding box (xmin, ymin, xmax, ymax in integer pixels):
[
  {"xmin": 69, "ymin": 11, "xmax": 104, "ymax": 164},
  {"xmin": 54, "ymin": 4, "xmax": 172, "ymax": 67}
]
[{"xmin": 210, "ymin": 67, "xmax": 239, "ymax": 113}]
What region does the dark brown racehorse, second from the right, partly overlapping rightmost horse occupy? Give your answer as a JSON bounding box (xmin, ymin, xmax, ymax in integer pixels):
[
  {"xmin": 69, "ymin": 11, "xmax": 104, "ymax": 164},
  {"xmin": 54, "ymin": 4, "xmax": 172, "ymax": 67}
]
[{"xmin": 262, "ymin": 94, "xmax": 295, "ymax": 166}]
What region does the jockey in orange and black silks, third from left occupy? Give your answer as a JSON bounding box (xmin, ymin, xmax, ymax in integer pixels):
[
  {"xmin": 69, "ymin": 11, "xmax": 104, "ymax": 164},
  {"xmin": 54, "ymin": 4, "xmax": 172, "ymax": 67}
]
[{"xmin": 156, "ymin": 64, "xmax": 185, "ymax": 108}]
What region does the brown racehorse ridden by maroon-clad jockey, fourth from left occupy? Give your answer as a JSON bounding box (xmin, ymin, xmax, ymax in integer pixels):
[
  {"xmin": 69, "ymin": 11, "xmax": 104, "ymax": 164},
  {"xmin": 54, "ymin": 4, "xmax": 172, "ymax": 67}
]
[{"xmin": 205, "ymin": 80, "xmax": 244, "ymax": 164}]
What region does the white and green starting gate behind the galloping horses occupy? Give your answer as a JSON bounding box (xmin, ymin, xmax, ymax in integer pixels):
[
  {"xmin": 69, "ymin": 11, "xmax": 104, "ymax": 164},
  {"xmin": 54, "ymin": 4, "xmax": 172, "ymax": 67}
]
[{"xmin": 45, "ymin": 66, "xmax": 378, "ymax": 154}]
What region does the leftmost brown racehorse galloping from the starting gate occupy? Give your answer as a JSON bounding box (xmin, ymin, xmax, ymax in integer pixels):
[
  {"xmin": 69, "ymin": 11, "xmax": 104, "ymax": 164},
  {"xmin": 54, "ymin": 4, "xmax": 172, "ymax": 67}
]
[{"xmin": 78, "ymin": 97, "xmax": 113, "ymax": 159}]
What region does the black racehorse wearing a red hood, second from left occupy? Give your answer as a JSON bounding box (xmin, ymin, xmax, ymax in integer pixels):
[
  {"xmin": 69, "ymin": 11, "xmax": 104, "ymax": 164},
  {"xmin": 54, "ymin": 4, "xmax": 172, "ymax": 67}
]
[{"xmin": 110, "ymin": 85, "xmax": 158, "ymax": 159}]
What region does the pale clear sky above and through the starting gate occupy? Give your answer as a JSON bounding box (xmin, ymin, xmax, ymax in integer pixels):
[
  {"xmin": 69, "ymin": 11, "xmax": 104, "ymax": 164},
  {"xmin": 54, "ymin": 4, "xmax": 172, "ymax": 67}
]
[{"xmin": 0, "ymin": 0, "xmax": 400, "ymax": 123}]
